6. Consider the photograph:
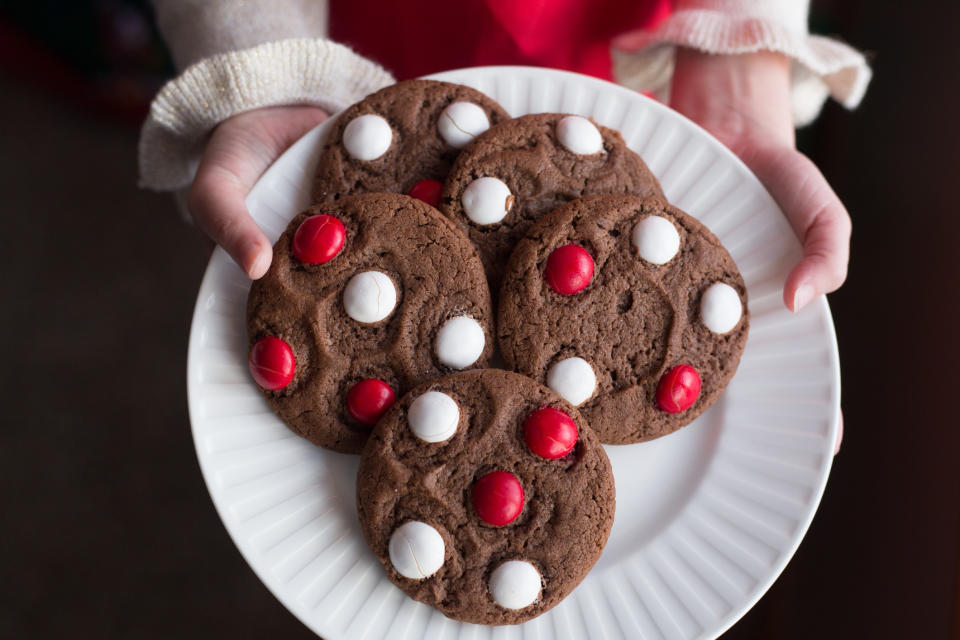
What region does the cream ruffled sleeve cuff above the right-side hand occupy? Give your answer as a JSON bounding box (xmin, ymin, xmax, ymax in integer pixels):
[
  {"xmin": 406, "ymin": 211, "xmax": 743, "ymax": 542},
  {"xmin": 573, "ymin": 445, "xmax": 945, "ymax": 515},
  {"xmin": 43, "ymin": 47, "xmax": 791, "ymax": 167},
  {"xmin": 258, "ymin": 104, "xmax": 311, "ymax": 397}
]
[{"xmin": 612, "ymin": 5, "xmax": 871, "ymax": 126}]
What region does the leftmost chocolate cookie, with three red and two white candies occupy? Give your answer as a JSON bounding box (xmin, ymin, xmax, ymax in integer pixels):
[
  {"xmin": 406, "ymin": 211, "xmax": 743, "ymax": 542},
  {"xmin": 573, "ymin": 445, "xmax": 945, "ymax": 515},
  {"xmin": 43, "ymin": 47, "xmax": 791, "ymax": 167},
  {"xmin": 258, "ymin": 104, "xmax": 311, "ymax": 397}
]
[{"xmin": 247, "ymin": 194, "xmax": 493, "ymax": 453}]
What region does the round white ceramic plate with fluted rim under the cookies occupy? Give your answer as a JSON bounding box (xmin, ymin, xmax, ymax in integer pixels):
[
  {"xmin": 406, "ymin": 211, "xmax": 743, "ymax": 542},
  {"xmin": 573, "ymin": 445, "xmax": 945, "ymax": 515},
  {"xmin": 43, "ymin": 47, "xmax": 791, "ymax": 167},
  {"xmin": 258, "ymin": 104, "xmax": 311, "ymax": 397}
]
[{"xmin": 187, "ymin": 67, "xmax": 840, "ymax": 640}]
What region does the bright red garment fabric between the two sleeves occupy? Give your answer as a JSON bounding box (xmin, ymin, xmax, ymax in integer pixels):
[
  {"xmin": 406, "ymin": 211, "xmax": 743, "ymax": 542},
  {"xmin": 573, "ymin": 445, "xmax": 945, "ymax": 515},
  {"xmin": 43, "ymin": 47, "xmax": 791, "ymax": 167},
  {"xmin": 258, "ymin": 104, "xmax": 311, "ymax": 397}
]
[{"xmin": 330, "ymin": 0, "xmax": 671, "ymax": 80}]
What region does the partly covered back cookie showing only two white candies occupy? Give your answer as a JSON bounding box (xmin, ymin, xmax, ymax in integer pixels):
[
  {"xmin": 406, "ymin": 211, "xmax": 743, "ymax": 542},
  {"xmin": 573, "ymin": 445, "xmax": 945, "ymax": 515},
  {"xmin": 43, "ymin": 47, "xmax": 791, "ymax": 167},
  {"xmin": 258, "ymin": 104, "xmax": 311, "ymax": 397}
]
[{"xmin": 441, "ymin": 113, "xmax": 663, "ymax": 288}]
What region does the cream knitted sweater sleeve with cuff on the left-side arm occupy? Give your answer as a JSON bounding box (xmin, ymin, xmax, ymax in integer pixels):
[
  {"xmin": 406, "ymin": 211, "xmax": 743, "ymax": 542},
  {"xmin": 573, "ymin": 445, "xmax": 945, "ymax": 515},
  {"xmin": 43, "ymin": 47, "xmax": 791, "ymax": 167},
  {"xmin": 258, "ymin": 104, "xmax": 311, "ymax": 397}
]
[{"xmin": 138, "ymin": 0, "xmax": 394, "ymax": 191}]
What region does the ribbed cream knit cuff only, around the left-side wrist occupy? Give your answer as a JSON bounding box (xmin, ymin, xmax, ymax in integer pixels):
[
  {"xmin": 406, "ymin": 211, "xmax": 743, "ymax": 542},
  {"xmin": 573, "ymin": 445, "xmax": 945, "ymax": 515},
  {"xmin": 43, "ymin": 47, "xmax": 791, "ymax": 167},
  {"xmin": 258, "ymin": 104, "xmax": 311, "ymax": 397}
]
[{"xmin": 139, "ymin": 38, "xmax": 394, "ymax": 191}]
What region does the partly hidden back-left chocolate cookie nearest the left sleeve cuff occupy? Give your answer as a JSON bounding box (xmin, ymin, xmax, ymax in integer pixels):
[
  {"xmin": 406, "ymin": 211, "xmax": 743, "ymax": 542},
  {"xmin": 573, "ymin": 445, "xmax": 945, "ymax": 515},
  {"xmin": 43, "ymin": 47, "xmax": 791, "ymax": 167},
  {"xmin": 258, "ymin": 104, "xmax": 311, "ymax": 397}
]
[{"xmin": 313, "ymin": 80, "xmax": 510, "ymax": 206}]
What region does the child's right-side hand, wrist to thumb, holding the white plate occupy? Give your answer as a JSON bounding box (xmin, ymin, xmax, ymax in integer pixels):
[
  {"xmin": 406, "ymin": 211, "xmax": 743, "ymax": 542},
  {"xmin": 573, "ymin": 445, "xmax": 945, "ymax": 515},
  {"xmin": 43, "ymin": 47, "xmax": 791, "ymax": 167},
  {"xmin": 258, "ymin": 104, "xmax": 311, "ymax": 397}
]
[{"xmin": 670, "ymin": 49, "xmax": 850, "ymax": 311}]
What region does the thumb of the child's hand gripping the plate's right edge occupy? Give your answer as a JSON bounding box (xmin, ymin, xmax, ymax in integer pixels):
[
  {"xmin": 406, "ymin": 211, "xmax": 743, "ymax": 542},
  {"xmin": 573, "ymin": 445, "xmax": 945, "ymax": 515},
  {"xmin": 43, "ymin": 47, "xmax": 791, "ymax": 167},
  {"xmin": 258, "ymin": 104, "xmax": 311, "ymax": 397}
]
[{"xmin": 745, "ymin": 148, "xmax": 851, "ymax": 311}]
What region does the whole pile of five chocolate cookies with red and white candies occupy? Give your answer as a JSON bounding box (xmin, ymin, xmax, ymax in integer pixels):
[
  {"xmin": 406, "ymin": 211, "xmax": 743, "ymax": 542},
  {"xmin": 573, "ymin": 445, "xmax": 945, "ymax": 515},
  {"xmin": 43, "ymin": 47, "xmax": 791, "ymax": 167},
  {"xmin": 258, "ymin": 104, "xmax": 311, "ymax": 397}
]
[{"xmin": 247, "ymin": 80, "xmax": 748, "ymax": 624}]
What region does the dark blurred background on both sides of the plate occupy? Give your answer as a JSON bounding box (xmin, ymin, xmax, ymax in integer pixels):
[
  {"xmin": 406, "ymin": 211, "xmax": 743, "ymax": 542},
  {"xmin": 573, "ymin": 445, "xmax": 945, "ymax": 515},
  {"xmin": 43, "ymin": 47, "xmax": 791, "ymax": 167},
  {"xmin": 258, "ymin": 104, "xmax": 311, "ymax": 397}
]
[{"xmin": 0, "ymin": 0, "xmax": 960, "ymax": 640}]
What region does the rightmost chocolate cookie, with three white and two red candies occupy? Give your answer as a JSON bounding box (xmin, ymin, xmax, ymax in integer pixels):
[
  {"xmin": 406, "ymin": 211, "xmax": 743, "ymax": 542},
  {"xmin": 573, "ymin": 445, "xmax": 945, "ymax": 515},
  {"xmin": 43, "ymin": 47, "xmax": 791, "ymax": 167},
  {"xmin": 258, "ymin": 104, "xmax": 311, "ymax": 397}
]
[{"xmin": 497, "ymin": 196, "xmax": 749, "ymax": 444}]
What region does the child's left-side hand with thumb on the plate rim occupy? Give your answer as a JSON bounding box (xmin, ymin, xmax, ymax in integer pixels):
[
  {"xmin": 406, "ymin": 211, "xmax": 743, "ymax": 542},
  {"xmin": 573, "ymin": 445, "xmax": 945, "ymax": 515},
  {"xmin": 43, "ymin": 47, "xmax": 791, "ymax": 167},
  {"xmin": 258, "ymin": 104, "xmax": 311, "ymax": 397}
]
[{"xmin": 187, "ymin": 106, "xmax": 327, "ymax": 280}]
